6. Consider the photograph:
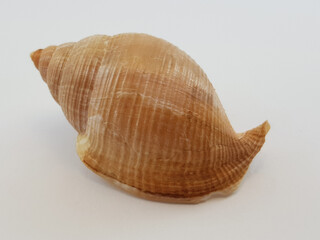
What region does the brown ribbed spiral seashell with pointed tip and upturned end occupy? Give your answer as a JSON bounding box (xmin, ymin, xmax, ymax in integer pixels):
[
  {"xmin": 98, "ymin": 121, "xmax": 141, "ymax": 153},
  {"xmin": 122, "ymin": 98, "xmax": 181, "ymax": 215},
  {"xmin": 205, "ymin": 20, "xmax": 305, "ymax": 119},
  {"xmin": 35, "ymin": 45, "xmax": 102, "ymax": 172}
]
[{"xmin": 31, "ymin": 34, "xmax": 270, "ymax": 203}]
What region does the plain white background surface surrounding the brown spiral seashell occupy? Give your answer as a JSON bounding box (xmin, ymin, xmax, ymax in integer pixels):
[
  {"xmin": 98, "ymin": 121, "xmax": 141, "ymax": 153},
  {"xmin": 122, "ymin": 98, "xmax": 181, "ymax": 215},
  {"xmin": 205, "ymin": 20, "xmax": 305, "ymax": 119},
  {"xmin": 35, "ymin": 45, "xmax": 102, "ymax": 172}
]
[{"xmin": 0, "ymin": 0, "xmax": 320, "ymax": 240}]
